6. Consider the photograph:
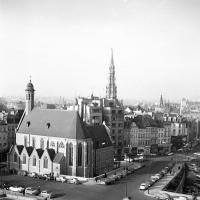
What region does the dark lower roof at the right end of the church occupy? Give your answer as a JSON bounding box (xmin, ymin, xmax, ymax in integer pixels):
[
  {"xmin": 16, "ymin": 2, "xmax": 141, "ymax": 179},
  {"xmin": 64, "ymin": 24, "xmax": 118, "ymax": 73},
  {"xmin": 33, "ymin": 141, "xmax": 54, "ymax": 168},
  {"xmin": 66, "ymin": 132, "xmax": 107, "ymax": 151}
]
[{"xmin": 86, "ymin": 125, "xmax": 112, "ymax": 149}]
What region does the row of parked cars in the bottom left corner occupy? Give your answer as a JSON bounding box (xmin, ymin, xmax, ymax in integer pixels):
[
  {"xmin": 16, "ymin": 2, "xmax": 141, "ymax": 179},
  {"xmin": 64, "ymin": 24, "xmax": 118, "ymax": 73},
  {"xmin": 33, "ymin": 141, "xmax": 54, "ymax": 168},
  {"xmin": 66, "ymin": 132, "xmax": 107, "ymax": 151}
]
[{"xmin": 0, "ymin": 183, "xmax": 53, "ymax": 198}]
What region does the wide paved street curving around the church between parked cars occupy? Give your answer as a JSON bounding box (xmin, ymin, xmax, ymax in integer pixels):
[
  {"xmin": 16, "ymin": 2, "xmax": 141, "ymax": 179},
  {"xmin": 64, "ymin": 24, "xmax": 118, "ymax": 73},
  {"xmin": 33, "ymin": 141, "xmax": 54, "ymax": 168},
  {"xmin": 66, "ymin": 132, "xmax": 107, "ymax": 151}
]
[{"xmin": 0, "ymin": 160, "xmax": 169, "ymax": 200}]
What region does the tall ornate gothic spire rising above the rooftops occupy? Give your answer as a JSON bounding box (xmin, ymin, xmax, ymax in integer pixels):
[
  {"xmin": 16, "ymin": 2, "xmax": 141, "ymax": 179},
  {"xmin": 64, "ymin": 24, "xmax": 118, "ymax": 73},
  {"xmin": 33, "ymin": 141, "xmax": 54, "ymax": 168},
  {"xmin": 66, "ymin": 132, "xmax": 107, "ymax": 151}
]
[{"xmin": 106, "ymin": 49, "xmax": 117, "ymax": 99}]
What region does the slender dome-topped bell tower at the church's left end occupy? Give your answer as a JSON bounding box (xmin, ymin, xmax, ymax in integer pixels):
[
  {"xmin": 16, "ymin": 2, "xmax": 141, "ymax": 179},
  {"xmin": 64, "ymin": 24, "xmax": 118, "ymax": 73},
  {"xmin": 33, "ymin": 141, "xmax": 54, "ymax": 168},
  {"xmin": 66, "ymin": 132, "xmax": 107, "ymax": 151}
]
[{"xmin": 25, "ymin": 79, "xmax": 35, "ymax": 115}]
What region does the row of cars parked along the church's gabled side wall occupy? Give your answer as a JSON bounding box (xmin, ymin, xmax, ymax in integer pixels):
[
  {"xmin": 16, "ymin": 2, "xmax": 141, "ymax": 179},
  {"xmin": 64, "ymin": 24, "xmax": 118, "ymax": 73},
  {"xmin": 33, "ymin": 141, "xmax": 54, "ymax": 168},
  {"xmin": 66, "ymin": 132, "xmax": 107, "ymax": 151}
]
[{"xmin": 18, "ymin": 171, "xmax": 81, "ymax": 184}]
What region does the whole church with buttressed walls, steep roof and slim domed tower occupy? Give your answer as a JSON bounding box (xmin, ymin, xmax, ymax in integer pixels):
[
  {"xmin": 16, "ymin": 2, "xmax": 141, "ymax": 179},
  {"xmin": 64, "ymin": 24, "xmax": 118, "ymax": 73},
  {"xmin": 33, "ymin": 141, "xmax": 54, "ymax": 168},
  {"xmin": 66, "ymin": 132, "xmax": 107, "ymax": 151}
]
[{"xmin": 8, "ymin": 81, "xmax": 114, "ymax": 177}]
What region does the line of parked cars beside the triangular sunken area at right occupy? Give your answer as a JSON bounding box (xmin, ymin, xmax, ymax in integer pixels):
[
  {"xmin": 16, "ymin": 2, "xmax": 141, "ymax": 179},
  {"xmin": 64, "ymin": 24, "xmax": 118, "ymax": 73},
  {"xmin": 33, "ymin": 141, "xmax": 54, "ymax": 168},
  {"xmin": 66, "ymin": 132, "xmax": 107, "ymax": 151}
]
[{"xmin": 139, "ymin": 166, "xmax": 172, "ymax": 190}]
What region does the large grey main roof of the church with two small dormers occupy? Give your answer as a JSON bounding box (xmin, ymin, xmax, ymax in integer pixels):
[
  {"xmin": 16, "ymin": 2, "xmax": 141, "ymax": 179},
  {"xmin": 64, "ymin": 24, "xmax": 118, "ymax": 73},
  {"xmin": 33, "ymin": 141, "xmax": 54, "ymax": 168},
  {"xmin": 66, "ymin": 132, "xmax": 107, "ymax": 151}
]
[{"xmin": 18, "ymin": 108, "xmax": 86, "ymax": 139}]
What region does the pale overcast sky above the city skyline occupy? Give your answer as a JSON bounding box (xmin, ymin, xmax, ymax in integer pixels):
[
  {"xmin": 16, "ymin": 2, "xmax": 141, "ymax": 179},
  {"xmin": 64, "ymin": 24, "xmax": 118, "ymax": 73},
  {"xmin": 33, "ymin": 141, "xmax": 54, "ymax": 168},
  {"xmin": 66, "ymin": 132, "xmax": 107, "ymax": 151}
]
[{"xmin": 0, "ymin": 0, "xmax": 200, "ymax": 100}]
